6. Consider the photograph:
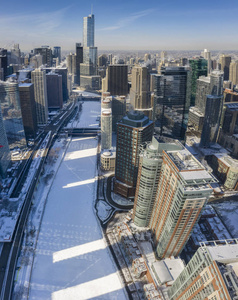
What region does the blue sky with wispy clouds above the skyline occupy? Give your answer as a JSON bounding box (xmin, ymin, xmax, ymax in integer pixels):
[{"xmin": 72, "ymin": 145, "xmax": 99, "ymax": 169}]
[{"xmin": 0, "ymin": 0, "xmax": 238, "ymax": 50}]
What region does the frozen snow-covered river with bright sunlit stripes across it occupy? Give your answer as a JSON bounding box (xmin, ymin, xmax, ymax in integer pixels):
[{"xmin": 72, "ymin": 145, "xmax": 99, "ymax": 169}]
[{"xmin": 29, "ymin": 102, "xmax": 126, "ymax": 300}]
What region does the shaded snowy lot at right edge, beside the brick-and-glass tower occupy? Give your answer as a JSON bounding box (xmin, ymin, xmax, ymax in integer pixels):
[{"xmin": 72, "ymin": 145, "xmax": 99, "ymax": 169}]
[{"xmin": 212, "ymin": 201, "xmax": 238, "ymax": 238}]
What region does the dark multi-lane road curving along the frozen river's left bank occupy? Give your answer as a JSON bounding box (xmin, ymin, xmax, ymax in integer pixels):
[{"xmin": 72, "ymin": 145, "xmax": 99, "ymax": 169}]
[{"xmin": 0, "ymin": 103, "xmax": 77, "ymax": 300}]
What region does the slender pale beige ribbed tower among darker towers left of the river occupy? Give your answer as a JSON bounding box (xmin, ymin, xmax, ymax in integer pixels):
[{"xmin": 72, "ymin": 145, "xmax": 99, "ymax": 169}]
[{"xmin": 31, "ymin": 68, "xmax": 48, "ymax": 125}]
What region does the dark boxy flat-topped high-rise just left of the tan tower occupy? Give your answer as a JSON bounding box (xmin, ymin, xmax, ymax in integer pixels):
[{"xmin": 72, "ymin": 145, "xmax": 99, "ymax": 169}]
[{"xmin": 105, "ymin": 65, "xmax": 128, "ymax": 96}]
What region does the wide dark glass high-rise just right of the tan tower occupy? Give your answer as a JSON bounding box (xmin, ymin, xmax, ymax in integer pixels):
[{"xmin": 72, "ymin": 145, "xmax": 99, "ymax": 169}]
[{"xmin": 154, "ymin": 67, "xmax": 191, "ymax": 140}]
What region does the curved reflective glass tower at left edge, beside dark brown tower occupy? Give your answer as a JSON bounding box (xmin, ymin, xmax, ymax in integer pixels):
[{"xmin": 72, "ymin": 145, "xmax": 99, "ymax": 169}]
[{"xmin": 0, "ymin": 82, "xmax": 26, "ymax": 149}]
